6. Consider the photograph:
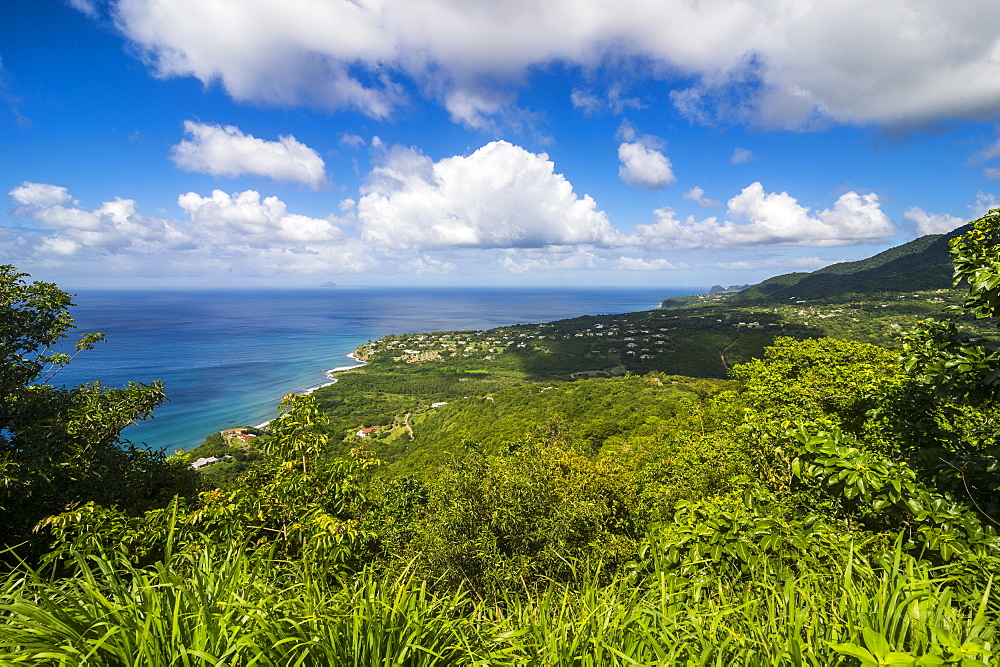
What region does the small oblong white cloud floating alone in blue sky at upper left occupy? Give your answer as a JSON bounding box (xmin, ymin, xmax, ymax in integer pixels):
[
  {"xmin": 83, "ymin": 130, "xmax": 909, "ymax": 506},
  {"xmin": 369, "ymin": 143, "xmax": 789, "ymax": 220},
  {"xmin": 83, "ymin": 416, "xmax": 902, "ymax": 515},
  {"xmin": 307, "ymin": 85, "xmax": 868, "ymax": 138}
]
[{"xmin": 170, "ymin": 120, "xmax": 327, "ymax": 189}]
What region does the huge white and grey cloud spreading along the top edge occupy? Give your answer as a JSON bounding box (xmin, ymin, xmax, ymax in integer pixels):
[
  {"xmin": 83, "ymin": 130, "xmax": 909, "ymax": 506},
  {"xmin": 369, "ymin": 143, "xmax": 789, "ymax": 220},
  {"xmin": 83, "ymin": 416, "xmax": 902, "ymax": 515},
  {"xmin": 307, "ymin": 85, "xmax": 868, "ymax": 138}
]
[{"xmin": 99, "ymin": 0, "xmax": 1000, "ymax": 127}]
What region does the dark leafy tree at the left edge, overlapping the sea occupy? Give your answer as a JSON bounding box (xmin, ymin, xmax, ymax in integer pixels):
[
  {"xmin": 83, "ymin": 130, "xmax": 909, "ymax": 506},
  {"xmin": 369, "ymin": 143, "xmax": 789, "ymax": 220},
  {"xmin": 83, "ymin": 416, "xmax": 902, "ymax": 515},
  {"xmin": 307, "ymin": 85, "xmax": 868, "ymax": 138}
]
[{"xmin": 0, "ymin": 265, "xmax": 196, "ymax": 556}]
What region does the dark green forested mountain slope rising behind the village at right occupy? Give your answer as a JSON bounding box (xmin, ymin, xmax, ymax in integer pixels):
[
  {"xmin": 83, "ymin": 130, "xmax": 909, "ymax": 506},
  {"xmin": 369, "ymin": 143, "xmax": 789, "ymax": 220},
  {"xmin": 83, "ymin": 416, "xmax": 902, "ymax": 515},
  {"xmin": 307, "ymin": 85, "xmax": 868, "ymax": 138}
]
[{"xmin": 730, "ymin": 225, "xmax": 969, "ymax": 304}]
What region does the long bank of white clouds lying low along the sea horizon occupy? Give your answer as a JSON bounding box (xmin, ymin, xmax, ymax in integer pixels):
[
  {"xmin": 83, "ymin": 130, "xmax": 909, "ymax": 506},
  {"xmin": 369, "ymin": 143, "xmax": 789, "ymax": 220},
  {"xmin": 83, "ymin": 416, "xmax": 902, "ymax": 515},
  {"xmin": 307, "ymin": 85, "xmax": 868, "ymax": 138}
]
[{"xmin": 0, "ymin": 140, "xmax": 908, "ymax": 284}]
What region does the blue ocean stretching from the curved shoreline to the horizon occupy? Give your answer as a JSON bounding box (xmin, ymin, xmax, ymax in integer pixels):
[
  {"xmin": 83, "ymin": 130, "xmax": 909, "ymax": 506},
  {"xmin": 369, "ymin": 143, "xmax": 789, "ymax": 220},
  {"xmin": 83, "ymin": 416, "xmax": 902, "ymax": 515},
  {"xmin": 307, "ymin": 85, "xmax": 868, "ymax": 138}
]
[{"xmin": 53, "ymin": 287, "xmax": 705, "ymax": 451}]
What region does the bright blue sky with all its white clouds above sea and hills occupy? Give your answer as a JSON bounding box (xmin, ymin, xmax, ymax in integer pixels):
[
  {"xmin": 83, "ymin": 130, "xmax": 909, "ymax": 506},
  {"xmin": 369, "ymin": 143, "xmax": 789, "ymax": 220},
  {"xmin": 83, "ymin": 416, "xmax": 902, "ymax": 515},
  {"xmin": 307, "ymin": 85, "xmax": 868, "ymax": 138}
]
[{"xmin": 0, "ymin": 0, "xmax": 1000, "ymax": 288}]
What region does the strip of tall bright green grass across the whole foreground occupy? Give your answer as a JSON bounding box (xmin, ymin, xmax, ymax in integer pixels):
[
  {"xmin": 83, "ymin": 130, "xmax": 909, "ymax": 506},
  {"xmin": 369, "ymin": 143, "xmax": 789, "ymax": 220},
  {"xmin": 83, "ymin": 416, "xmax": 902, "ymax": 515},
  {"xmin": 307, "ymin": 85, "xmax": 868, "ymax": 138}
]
[{"xmin": 0, "ymin": 545, "xmax": 997, "ymax": 667}]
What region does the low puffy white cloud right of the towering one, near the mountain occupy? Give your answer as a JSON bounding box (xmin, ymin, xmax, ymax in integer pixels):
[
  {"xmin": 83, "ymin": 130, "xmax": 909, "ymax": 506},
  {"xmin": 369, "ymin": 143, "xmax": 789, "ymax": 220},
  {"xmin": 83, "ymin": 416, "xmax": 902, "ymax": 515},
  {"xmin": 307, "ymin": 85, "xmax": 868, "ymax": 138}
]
[{"xmin": 636, "ymin": 182, "xmax": 896, "ymax": 248}]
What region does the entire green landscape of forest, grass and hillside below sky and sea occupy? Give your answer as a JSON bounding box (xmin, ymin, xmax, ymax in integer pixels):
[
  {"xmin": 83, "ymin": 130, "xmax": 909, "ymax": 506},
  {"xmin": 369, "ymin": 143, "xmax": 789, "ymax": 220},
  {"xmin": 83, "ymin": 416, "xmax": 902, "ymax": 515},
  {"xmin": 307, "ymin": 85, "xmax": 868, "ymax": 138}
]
[{"xmin": 0, "ymin": 210, "xmax": 1000, "ymax": 666}]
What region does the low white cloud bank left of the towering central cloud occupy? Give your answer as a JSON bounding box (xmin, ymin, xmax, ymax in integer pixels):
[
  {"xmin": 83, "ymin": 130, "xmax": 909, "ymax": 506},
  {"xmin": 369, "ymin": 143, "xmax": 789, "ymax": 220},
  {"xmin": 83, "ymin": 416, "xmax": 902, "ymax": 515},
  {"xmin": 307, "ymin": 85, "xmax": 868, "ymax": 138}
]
[{"xmin": 0, "ymin": 183, "xmax": 364, "ymax": 276}]
